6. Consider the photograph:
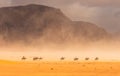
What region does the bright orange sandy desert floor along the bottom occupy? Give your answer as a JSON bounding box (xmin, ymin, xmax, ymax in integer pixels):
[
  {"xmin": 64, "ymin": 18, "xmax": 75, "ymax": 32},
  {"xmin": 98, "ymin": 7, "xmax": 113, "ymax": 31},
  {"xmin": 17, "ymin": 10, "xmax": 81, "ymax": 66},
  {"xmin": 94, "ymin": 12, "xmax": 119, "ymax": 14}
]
[{"xmin": 0, "ymin": 60, "xmax": 120, "ymax": 76}]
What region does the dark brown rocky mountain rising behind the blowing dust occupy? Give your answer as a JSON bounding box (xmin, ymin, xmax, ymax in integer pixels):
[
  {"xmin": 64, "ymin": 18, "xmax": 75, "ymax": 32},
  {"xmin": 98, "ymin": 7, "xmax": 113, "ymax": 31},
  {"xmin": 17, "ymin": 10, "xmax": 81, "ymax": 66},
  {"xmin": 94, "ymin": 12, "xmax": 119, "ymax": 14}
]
[{"xmin": 0, "ymin": 5, "xmax": 108, "ymax": 42}]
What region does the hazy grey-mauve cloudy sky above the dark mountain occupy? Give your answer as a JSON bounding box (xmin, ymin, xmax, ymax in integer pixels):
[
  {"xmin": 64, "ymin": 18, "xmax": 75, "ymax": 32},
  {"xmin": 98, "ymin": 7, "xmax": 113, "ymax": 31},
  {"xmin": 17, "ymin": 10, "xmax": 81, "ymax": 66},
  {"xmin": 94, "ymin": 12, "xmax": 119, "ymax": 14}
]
[{"xmin": 0, "ymin": 0, "xmax": 120, "ymax": 32}]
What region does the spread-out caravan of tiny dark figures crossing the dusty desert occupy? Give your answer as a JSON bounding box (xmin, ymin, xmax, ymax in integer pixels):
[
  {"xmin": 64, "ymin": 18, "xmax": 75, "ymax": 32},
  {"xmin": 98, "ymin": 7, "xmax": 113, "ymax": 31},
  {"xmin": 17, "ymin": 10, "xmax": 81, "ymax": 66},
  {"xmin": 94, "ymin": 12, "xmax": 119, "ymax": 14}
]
[{"xmin": 21, "ymin": 56, "xmax": 99, "ymax": 61}]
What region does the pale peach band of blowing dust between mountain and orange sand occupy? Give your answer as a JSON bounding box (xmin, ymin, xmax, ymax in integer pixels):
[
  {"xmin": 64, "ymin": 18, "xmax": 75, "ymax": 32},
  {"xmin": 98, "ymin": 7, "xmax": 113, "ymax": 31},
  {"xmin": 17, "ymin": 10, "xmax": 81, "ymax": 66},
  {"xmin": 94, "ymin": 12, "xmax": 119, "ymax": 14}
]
[{"xmin": 0, "ymin": 34, "xmax": 120, "ymax": 61}]
